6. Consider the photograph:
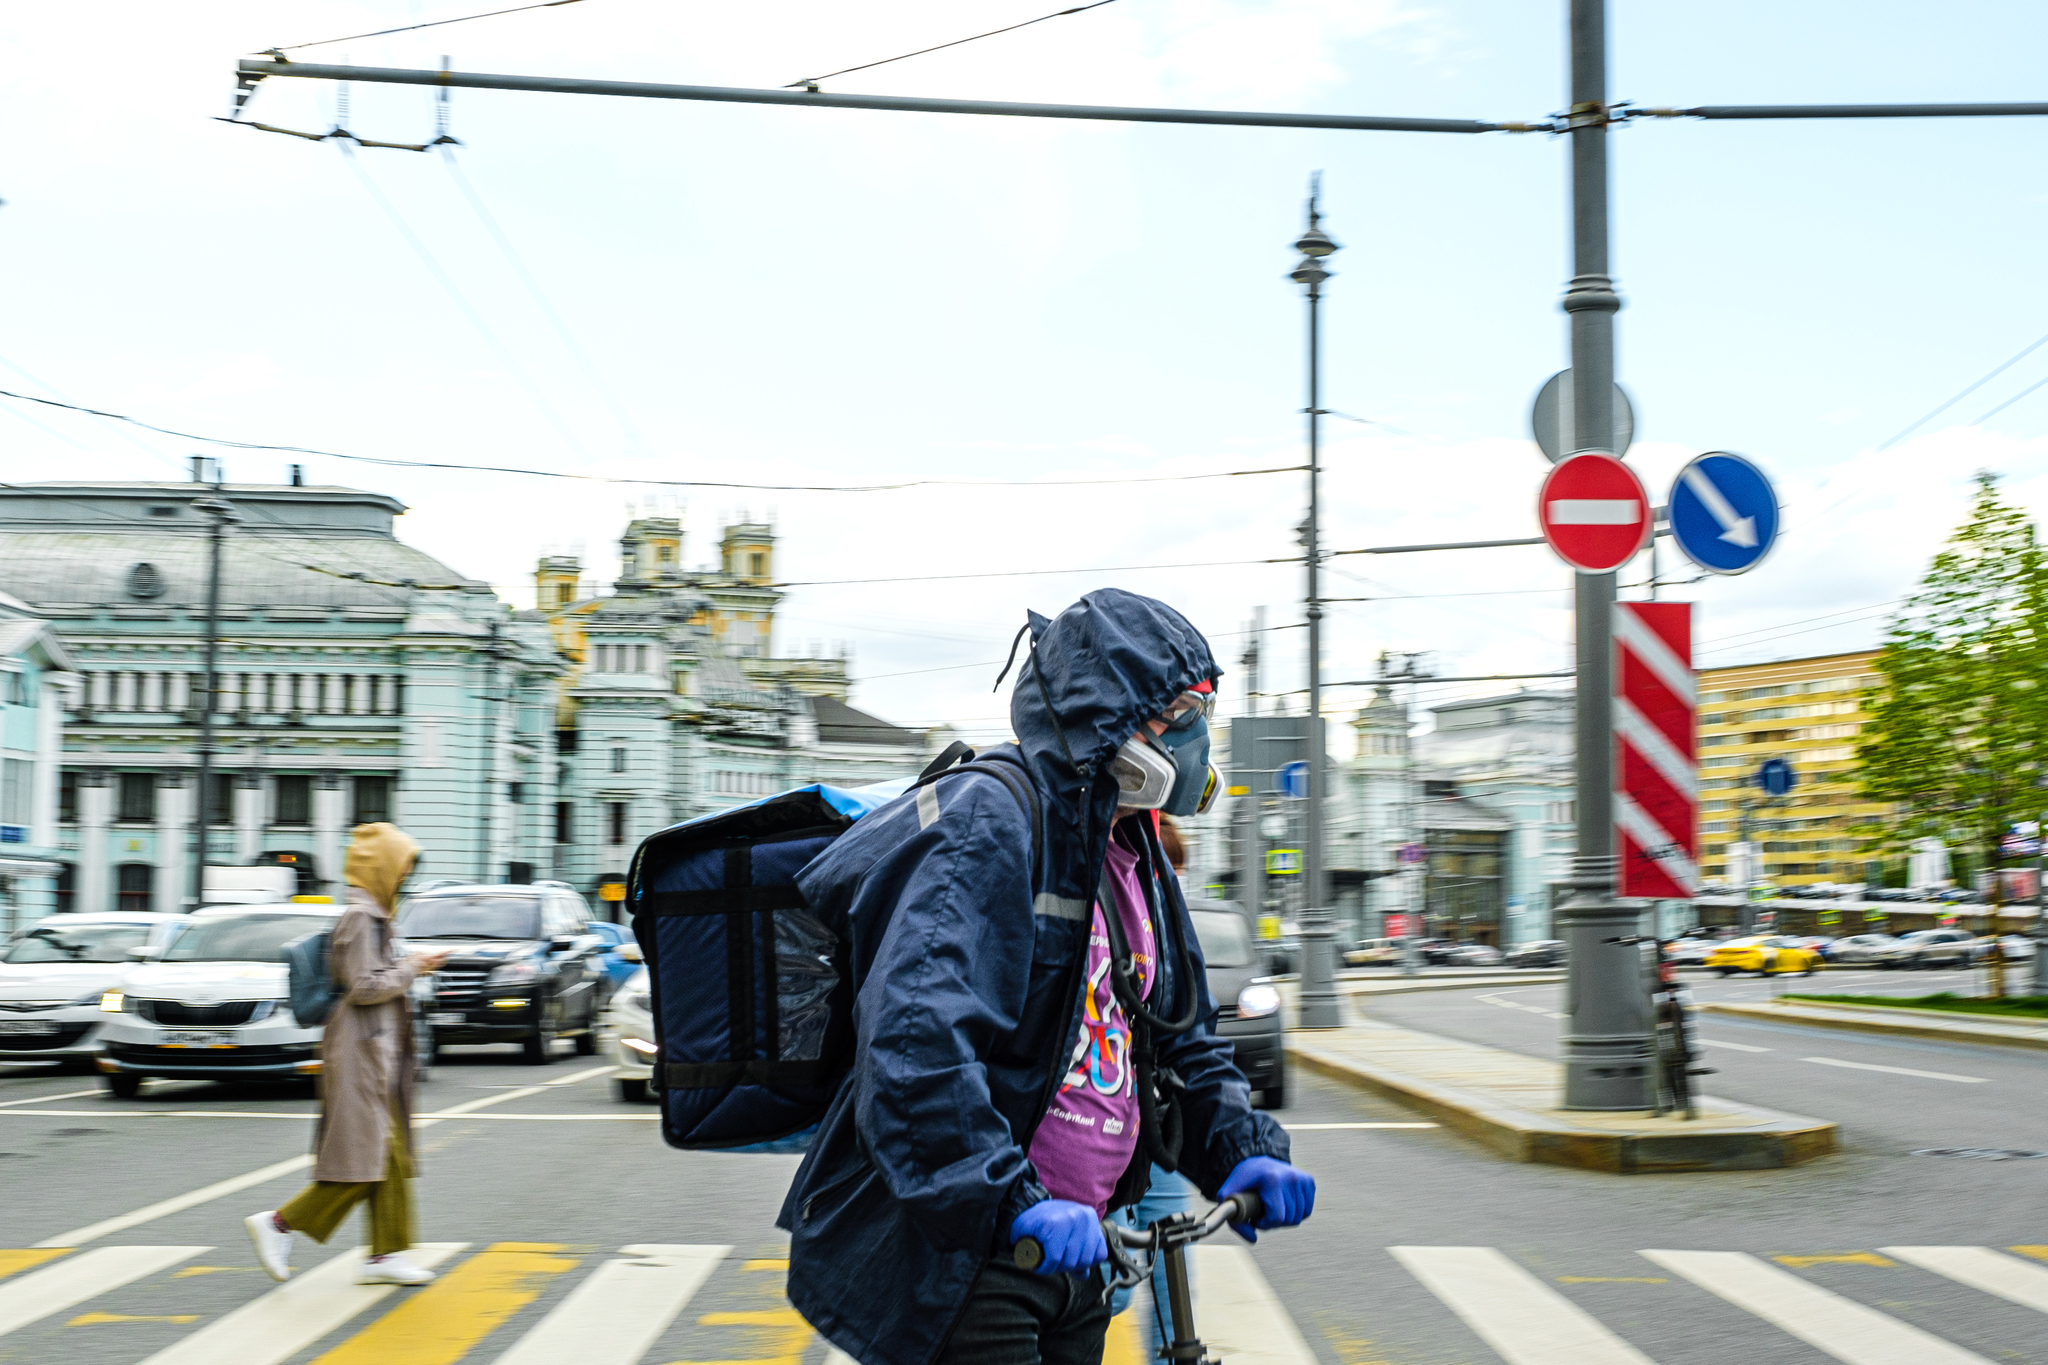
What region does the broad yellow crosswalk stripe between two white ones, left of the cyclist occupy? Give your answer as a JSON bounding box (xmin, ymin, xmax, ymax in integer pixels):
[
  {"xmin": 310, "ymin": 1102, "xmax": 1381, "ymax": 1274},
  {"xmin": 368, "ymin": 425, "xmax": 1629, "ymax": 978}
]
[{"xmin": 313, "ymin": 1242, "xmax": 578, "ymax": 1365}]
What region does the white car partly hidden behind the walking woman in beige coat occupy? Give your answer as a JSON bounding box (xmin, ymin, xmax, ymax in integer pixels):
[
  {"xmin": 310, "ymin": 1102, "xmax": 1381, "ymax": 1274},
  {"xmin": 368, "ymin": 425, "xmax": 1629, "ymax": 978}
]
[{"xmin": 98, "ymin": 905, "xmax": 340, "ymax": 1099}]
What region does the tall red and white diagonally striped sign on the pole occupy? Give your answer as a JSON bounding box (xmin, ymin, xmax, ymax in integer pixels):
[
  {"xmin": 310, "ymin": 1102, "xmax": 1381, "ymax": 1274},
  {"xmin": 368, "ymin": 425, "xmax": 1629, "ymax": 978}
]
[{"xmin": 1614, "ymin": 602, "xmax": 1700, "ymax": 900}]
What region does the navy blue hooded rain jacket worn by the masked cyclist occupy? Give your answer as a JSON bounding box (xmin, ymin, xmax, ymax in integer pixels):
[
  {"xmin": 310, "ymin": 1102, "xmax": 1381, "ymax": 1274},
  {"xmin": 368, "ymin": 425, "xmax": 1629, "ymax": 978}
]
[{"xmin": 778, "ymin": 589, "xmax": 1288, "ymax": 1365}]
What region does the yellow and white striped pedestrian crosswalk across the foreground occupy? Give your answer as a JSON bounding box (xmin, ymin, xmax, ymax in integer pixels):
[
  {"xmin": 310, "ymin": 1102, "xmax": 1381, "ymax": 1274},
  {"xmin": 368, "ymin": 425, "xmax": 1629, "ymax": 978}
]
[{"xmin": 0, "ymin": 1242, "xmax": 2048, "ymax": 1365}]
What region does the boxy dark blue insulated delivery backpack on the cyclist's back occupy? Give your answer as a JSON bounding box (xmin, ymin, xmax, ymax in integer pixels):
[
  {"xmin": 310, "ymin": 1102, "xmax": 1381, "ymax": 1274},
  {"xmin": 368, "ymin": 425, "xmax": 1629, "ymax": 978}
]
[{"xmin": 627, "ymin": 745, "xmax": 1042, "ymax": 1152}]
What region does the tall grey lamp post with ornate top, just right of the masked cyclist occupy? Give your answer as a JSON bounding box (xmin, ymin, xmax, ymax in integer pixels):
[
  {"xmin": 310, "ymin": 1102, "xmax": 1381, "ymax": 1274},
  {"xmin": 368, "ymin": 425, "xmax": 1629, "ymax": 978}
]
[{"xmin": 1288, "ymin": 187, "xmax": 1343, "ymax": 1029}]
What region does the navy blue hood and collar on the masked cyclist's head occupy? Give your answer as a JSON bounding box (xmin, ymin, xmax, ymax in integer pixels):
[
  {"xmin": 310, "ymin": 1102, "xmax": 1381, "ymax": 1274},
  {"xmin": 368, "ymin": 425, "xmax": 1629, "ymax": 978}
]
[{"xmin": 1010, "ymin": 587, "xmax": 1223, "ymax": 896}]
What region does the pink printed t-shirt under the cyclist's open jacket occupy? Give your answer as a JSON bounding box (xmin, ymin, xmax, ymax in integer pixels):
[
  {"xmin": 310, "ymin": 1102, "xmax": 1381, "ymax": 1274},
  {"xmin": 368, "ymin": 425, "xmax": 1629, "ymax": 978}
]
[{"xmin": 1030, "ymin": 841, "xmax": 1159, "ymax": 1214}]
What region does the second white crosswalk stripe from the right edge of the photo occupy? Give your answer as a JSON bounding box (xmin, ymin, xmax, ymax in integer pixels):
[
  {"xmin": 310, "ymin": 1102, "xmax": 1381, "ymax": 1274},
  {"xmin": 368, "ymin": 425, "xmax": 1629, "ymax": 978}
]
[{"xmin": 1642, "ymin": 1250, "xmax": 1989, "ymax": 1365}]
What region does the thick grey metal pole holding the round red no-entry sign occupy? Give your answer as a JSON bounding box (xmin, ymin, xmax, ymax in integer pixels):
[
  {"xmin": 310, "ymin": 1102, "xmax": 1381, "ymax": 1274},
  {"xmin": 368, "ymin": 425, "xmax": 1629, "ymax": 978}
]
[{"xmin": 1559, "ymin": 0, "xmax": 1651, "ymax": 1109}]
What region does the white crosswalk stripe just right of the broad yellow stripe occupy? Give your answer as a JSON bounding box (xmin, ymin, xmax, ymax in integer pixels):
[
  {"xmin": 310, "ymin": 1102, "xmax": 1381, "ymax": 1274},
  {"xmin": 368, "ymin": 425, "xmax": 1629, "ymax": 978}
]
[{"xmin": 487, "ymin": 1244, "xmax": 733, "ymax": 1365}]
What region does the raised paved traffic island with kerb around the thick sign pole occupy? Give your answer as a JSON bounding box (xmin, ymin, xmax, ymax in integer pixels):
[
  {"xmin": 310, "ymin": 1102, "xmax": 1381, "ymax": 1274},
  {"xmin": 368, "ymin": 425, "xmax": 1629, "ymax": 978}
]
[{"xmin": 1286, "ymin": 1010, "xmax": 1837, "ymax": 1173}]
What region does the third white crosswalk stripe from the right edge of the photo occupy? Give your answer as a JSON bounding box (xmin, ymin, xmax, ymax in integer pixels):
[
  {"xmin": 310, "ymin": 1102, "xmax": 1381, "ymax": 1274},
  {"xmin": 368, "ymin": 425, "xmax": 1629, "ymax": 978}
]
[{"xmin": 1386, "ymin": 1246, "xmax": 1655, "ymax": 1365}]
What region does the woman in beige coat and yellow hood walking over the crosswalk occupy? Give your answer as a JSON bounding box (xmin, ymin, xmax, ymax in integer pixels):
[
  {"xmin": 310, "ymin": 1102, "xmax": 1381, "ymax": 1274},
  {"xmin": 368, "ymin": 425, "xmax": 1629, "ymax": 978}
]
[{"xmin": 244, "ymin": 823, "xmax": 449, "ymax": 1285}]
